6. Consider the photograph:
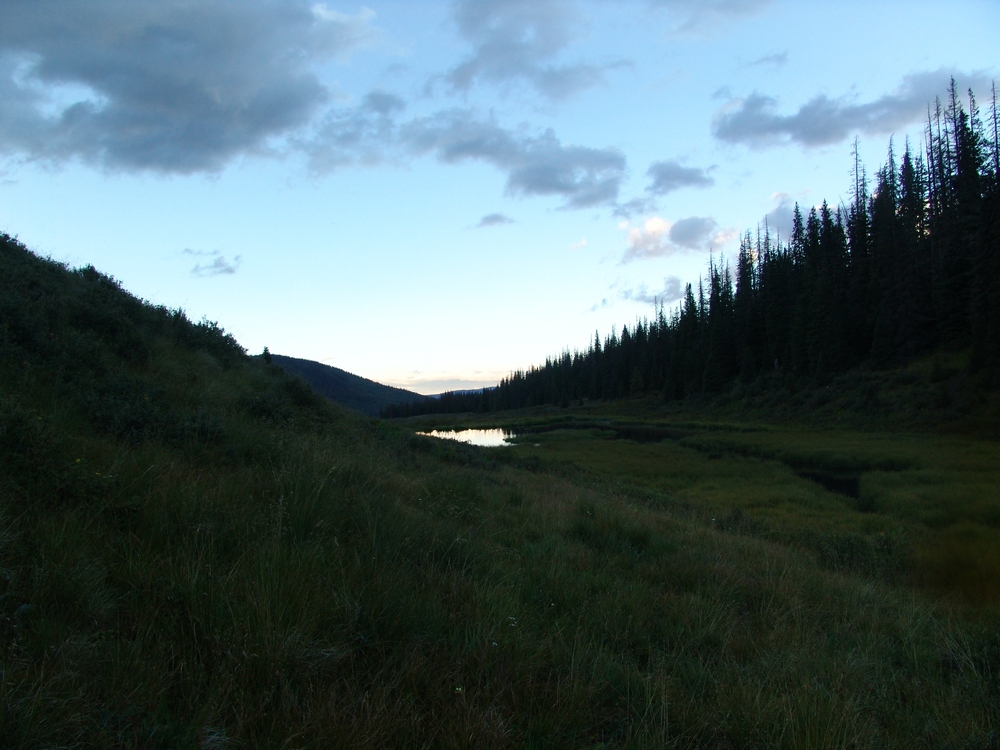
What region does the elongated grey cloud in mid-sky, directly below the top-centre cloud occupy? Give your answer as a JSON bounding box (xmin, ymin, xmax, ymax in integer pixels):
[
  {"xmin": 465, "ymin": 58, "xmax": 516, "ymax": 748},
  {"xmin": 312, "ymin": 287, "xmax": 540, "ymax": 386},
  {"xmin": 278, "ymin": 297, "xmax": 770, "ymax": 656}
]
[{"xmin": 400, "ymin": 110, "xmax": 626, "ymax": 208}]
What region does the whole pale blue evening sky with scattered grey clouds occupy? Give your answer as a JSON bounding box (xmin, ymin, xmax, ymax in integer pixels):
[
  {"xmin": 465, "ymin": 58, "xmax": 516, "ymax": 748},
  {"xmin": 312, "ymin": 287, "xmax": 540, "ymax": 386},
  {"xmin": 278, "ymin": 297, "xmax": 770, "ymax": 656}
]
[{"xmin": 0, "ymin": 0, "xmax": 1000, "ymax": 393}]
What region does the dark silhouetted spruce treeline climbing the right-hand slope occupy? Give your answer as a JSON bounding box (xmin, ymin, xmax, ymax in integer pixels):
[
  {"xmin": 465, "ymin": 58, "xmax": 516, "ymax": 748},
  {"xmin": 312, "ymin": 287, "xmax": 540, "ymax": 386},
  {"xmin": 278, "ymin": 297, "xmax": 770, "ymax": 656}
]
[{"xmin": 382, "ymin": 86, "xmax": 1000, "ymax": 424}]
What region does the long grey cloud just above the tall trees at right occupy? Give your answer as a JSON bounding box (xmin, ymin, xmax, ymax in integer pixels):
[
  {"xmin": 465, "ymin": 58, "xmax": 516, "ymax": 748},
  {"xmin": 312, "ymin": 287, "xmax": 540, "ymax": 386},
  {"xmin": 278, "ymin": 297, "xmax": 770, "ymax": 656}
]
[{"xmin": 712, "ymin": 70, "xmax": 989, "ymax": 148}]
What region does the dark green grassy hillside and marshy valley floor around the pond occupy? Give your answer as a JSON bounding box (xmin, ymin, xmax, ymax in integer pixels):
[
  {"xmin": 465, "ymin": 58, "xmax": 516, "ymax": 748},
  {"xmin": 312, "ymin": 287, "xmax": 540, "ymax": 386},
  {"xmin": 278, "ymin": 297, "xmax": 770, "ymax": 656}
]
[{"xmin": 0, "ymin": 238, "xmax": 1000, "ymax": 749}]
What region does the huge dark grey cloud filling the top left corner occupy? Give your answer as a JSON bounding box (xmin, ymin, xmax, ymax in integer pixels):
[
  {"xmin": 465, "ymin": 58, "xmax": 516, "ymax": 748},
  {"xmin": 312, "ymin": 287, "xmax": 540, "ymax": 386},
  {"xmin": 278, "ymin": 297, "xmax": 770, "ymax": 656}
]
[{"xmin": 0, "ymin": 0, "xmax": 374, "ymax": 173}]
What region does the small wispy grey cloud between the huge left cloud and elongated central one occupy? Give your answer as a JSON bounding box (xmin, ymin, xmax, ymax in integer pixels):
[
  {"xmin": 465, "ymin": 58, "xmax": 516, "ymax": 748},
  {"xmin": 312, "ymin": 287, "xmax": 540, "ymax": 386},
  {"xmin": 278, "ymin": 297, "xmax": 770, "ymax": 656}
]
[{"xmin": 297, "ymin": 91, "xmax": 406, "ymax": 174}]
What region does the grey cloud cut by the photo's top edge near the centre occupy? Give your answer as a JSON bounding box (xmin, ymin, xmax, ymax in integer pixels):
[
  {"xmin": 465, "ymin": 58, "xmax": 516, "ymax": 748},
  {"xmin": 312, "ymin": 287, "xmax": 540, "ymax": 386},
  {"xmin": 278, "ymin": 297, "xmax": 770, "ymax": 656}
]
[{"xmin": 446, "ymin": 0, "xmax": 604, "ymax": 100}]
